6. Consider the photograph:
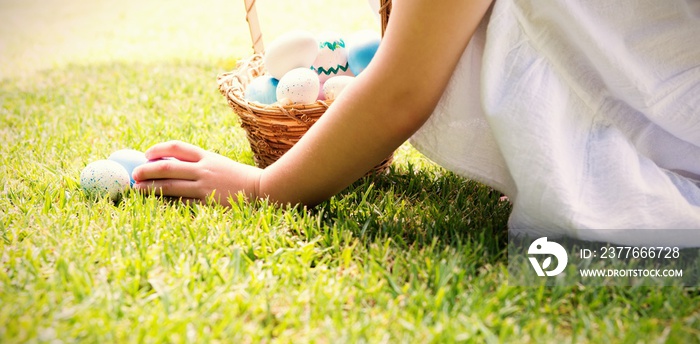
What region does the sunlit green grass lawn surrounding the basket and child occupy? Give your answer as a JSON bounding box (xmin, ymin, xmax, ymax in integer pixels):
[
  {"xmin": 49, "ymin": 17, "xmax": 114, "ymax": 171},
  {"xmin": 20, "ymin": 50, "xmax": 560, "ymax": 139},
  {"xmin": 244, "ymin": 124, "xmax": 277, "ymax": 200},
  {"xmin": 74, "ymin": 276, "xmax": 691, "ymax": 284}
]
[{"xmin": 0, "ymin": 0, "xmax": 700, "ymax": 343}]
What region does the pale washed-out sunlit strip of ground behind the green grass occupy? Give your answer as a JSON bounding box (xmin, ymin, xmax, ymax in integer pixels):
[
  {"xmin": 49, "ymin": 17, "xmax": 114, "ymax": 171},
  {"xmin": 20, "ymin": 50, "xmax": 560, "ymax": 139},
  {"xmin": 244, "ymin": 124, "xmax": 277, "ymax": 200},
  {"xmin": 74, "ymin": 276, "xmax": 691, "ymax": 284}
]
[{"xmin": 0, "ymin": 0, "xmax": 379, "ymax": 79}]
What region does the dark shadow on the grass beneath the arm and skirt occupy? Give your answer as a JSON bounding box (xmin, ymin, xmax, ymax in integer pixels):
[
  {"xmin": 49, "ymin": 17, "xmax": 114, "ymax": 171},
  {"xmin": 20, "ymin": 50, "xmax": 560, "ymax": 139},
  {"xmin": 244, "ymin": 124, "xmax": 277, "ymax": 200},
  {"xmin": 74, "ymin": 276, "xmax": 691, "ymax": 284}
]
[{"xmin": 315, "ymin": 163, "xmax": 511, "ymax": 263}]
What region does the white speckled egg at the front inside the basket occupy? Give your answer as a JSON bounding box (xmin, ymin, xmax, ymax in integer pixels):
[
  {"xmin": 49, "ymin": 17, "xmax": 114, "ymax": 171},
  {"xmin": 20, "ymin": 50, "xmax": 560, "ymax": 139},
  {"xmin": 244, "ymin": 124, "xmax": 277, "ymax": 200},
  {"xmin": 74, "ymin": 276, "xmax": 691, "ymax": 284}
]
[{"xmin": 277, "ymin": 68, "xmax": 321, "ymax": 105}]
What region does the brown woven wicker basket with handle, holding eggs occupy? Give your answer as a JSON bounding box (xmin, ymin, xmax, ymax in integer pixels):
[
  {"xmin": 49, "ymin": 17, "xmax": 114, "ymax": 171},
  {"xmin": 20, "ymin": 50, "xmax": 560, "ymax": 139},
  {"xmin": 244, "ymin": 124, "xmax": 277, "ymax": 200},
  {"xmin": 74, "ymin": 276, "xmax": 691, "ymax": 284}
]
[{"xmin": 217, "ymin": 0, "xmax": 393, "ymax": 173}]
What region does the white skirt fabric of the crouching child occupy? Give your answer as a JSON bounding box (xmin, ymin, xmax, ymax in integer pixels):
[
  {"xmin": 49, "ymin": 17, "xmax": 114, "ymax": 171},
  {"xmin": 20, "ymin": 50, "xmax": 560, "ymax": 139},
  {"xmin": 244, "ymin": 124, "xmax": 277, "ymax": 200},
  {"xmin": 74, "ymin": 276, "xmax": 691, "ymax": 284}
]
[{"xmin": 411, "ymin": 0, "xmax": 700, "ymax": 247}]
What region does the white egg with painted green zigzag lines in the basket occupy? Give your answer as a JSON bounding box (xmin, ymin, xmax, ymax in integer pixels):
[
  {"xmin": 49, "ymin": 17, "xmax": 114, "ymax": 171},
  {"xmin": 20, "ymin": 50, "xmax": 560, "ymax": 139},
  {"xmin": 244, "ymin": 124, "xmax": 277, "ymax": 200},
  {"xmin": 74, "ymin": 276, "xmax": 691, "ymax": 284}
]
[{"xmin": 311, "ymin": 31, "xmax": 352, "ymax": 83}]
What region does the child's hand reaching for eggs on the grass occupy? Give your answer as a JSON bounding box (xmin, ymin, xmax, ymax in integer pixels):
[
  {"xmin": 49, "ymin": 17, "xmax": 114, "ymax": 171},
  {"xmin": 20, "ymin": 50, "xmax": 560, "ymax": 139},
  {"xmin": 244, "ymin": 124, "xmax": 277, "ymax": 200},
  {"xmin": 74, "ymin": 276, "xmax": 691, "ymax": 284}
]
[{"xmin": 132, "ymin": 141, "xmax": 262, "ymax": 206}]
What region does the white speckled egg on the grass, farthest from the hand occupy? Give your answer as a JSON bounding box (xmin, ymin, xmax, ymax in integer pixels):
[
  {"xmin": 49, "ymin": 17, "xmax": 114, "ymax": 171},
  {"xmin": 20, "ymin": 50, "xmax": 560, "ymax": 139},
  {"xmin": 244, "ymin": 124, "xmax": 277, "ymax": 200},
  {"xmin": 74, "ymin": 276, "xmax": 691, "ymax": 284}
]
[{"xmin": 80, "ymin": 160, "xmax": 129, "ymax": 201}]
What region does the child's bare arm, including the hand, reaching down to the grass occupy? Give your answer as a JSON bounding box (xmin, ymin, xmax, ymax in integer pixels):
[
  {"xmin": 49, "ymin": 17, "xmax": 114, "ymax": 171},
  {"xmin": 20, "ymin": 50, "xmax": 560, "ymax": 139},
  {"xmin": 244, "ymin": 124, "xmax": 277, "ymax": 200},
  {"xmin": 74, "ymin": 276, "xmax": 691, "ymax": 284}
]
[{"xmin": 134, "ymin": 0, "xmax": 491, "ymax": 204}]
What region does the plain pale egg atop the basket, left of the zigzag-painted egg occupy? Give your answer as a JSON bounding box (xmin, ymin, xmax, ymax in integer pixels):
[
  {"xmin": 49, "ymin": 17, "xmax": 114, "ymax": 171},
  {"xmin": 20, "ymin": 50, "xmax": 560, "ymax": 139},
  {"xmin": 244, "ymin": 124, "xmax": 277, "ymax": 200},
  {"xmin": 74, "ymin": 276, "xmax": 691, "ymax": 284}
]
[{"xmin": 263, "ymin": 30, "xmax": 318, "ymax": 80}]
